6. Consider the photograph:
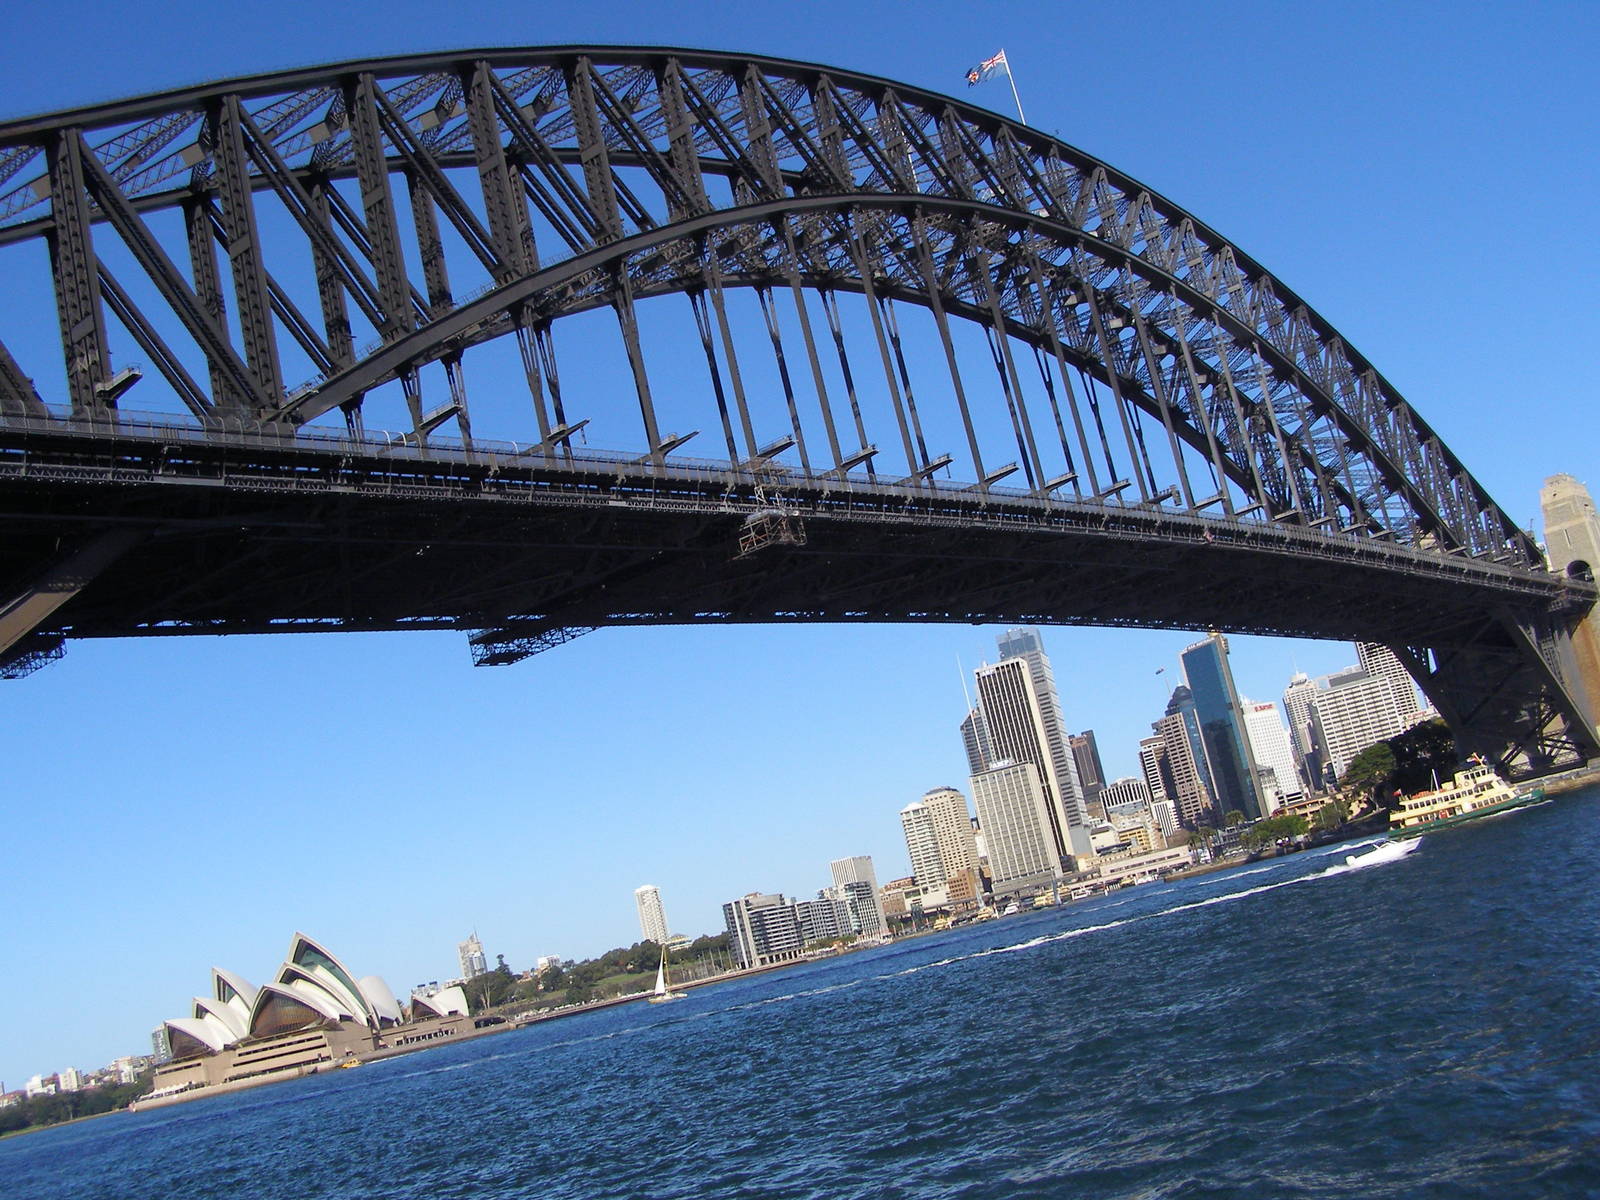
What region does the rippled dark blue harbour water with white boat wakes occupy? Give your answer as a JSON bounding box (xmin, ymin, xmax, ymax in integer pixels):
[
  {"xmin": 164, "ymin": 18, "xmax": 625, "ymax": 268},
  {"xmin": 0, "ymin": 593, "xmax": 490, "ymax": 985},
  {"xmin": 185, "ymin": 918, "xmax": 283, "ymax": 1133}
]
[{"xmin": 12, "ymin": 787, "xmax": 1600, "ymax": 1200}]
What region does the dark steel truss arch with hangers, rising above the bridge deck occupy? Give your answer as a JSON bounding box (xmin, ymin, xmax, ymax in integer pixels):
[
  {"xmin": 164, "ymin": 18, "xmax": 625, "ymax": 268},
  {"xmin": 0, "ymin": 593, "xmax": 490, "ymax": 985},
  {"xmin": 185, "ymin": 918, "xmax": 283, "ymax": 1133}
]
[{"xmin": 0, "ymin": 46, "xmax": 1595, "ymax": 765}]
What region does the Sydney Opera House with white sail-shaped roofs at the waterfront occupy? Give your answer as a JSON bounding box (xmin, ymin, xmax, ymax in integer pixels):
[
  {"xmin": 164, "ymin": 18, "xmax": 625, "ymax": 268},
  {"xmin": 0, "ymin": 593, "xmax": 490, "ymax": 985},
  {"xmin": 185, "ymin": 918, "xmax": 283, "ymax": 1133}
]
[{"xmin": 154, "ymin": 933, "xmax": 472, "ymax": 1094}]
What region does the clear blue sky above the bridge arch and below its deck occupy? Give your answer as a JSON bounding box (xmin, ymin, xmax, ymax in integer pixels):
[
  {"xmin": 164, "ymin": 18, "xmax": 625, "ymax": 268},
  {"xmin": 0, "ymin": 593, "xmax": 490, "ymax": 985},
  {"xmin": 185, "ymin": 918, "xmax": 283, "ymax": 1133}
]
[{"xmin": 0, "ymin": 0, "xmax": 1600, "ymax": 1086}]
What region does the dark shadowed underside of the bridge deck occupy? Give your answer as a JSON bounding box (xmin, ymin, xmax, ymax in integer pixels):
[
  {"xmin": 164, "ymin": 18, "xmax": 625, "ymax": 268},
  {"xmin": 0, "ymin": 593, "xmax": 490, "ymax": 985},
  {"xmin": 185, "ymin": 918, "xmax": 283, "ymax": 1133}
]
[{"xmin": 0, "ymin": 440, "xmax": 1574, "ymax": 659}]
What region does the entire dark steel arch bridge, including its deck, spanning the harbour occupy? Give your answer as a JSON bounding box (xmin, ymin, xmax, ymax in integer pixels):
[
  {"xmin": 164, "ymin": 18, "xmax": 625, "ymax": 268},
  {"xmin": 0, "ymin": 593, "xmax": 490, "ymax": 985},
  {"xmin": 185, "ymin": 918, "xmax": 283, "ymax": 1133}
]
[{"xmin": 0, "ymin": 46, "xmax": 1600, "ymax": 774}]
